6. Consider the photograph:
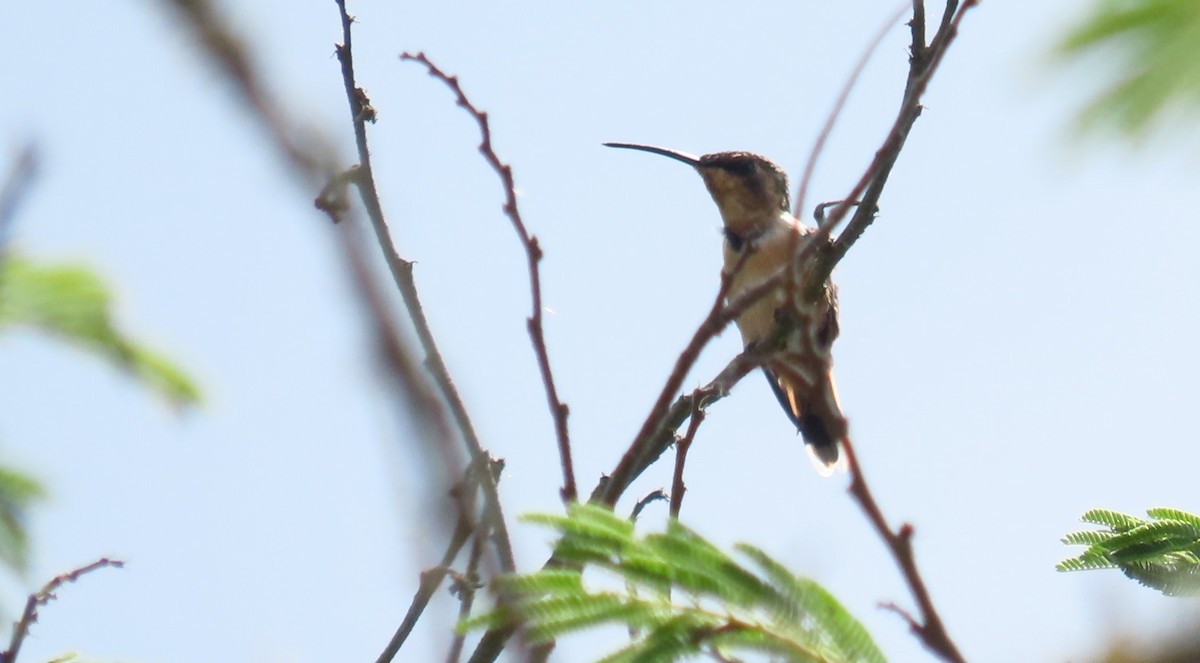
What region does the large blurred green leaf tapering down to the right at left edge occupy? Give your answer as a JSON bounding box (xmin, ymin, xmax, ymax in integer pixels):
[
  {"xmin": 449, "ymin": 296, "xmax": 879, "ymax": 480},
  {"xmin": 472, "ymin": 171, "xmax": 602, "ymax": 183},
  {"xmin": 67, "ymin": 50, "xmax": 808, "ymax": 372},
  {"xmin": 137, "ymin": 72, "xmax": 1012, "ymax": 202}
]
[{"xmin": 0, "ymin": 253, "xmax": 200, "ymax": 405}]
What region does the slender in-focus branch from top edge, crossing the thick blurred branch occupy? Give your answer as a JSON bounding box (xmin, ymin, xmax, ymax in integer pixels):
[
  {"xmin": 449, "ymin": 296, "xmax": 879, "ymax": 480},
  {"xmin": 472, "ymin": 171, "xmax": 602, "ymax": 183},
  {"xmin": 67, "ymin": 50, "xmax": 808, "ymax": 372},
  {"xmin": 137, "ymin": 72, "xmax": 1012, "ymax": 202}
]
[{"xmin": 331, "ymin": 0, "xmax": 516, "ymax": 573}]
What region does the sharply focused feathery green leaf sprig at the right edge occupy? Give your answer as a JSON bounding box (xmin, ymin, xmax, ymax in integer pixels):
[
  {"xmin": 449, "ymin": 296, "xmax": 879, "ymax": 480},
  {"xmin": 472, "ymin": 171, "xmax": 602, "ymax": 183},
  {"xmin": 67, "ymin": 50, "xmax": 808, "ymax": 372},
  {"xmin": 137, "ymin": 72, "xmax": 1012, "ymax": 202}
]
[{"xmin": 1055, "ymin": 508, "xmax": 1200, "ymax": 596}]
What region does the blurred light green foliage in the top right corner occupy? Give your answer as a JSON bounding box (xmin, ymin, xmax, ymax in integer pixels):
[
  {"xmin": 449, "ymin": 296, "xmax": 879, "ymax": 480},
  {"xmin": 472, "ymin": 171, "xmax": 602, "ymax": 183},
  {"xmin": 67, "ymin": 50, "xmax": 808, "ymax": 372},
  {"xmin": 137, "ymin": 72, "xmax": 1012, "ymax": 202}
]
[{"xmin": 1057, "ymin": 0, "xmax": 1200, "ymax": 136}]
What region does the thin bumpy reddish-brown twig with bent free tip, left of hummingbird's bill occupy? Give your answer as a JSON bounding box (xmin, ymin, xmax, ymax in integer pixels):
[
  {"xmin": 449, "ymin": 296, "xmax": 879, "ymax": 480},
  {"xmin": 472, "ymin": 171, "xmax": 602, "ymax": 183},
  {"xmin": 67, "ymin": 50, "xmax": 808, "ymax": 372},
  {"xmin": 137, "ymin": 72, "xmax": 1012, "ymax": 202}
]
[{"xmin": 400, "ymin": 53, "xmax": 578, "ymax": 502}]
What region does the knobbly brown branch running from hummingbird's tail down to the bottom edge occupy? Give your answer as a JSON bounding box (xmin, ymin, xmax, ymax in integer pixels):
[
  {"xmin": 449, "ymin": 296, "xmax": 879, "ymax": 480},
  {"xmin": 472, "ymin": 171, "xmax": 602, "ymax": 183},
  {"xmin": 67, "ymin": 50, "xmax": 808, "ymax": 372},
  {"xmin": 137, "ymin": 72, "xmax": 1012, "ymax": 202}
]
[{"xmin": 842, "ymin": 437, "xmax": 966, "ymax": 663}]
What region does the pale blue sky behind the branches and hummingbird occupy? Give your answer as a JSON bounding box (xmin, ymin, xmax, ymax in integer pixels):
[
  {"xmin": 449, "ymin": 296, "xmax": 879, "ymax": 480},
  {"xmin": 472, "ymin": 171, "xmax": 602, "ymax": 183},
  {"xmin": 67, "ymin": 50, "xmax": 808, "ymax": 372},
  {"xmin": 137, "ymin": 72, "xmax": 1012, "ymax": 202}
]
[{"xmin": 0, "ymin": 0, "xmax": 1200, "ymax": 663}]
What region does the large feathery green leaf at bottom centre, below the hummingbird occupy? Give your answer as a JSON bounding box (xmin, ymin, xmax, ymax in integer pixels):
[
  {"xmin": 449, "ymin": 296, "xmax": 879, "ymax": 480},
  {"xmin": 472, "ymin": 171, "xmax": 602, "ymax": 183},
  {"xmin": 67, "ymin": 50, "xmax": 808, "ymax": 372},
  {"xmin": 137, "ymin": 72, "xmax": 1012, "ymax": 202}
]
[{"xmin": 460, "ymin": 504, "xmax": 884, "ymax": 663}]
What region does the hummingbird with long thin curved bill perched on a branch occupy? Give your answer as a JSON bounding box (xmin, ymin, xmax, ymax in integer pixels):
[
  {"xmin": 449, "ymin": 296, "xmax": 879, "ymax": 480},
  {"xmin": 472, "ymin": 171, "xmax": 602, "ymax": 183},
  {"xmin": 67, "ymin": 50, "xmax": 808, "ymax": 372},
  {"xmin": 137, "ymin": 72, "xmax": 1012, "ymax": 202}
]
[{"xmin": 605, "ymin": 143, "xmax": 846, "ymax": 476}]
